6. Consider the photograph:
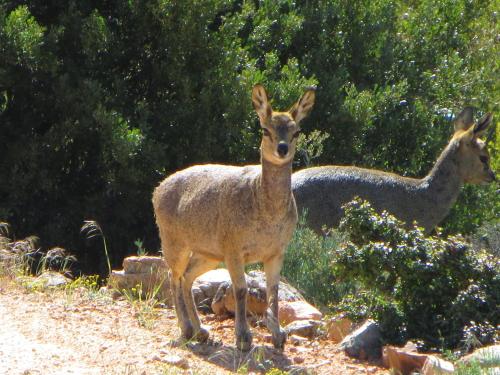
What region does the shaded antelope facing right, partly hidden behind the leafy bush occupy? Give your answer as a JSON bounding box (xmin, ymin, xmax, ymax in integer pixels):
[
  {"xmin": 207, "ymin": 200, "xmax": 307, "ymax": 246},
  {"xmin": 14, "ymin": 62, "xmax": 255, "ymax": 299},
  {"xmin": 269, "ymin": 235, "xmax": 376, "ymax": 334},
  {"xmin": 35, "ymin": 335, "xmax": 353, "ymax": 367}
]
[{"xmin": 292, "ymin": 107, "xmax": 495, "ymax": 233}]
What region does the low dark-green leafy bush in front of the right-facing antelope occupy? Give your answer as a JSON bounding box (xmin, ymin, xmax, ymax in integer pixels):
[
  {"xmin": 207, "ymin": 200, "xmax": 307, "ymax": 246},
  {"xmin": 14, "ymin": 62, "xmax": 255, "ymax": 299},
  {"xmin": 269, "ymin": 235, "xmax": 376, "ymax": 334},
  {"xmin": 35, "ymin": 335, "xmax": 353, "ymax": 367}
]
[{"xmin": 333, "ymin": 199, "xmax": 500, "ymax": 349}]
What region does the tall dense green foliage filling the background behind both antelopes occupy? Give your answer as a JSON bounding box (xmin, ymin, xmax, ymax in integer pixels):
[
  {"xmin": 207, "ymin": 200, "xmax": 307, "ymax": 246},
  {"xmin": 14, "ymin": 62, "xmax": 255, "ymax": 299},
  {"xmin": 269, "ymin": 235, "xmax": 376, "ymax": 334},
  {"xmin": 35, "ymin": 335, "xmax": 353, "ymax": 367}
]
[{"xmin": 0, "ymin": 0, "xmax": 500, "ymax": 272}]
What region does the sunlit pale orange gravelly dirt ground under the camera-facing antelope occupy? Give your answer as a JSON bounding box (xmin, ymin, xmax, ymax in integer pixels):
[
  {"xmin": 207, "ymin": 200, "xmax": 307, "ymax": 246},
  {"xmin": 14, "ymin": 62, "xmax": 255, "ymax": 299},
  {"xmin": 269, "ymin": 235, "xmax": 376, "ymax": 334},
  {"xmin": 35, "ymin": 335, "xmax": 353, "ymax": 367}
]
[{"xmin": 0, "ymin": 279, "xmax": 387, "ymax": 375}]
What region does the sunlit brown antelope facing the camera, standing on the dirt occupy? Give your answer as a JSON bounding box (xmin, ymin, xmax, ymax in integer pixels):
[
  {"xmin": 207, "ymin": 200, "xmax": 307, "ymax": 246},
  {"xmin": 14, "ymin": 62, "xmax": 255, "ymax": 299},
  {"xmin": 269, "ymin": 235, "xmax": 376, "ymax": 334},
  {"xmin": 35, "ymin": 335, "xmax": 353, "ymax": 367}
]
[{"xmin": 153, "ymin": 85, "xmax": 315, "ymax": 350}]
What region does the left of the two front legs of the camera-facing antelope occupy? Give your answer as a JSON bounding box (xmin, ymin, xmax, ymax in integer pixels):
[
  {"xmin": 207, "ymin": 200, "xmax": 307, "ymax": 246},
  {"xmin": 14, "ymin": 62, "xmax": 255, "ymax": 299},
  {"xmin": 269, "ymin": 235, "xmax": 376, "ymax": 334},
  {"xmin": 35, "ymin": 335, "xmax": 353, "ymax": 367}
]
[{"xmin": 225, "ymin": 254, "xmax": 252, "ymax": 351}]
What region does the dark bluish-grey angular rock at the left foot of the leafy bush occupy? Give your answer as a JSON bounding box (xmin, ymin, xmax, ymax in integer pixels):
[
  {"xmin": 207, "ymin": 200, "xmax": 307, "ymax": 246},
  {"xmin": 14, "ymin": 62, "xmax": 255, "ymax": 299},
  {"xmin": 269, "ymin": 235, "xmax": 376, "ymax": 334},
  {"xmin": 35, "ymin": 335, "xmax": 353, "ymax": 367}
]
[{"xmin": 340, "ymin": 320, "xmax": 382, "ymax": 359}]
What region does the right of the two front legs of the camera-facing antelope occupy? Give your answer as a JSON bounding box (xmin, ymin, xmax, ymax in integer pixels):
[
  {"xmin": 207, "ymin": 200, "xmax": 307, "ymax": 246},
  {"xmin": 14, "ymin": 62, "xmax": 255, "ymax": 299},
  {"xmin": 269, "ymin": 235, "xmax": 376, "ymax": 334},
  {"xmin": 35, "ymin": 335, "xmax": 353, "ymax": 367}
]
[{"xmin": 264, "ymin": 254, "xmax": 287, "ymax": 350}]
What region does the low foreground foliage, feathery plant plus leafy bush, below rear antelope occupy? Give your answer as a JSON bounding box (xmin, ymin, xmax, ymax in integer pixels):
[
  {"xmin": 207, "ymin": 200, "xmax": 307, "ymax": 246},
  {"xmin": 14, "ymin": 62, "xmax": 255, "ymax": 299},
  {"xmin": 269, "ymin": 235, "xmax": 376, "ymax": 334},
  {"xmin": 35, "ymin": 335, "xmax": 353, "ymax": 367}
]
[{"xmin": 282, "ymin": 199, "xmax": 500, "ymax": 352}]
